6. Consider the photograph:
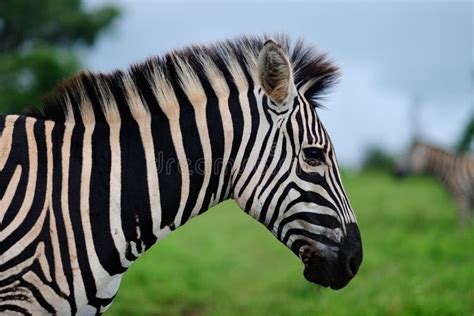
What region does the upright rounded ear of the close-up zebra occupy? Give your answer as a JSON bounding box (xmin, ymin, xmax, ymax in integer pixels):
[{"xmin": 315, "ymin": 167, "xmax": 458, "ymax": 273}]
[{"xmin": 257, "ymin": 40, "xmax": 295, "ymax": 104}]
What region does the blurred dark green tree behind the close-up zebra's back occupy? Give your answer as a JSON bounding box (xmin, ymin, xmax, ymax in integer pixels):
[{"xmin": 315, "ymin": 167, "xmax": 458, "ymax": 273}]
[{"xmin": 0, "ymin": 0, "xmax": 119, "ymax": 113}]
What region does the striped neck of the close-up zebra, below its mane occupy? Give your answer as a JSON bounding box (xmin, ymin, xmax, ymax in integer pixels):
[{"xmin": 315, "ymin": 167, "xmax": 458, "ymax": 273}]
[{"xmin": 56, "ymin": 97, "xmax": 238, "ymax": 264}]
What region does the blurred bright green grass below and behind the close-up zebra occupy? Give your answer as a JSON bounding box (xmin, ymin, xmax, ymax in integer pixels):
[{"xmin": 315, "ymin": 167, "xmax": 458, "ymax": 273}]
[{"xmin": 109, "ymin": 173, "xmax": 474, "ymax": 315}]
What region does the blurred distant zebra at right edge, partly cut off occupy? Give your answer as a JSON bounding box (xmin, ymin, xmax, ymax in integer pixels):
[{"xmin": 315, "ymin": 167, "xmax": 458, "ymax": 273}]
[{"xmin": 397, "ymin": 139, "xmax": 474, "ymax": 225}]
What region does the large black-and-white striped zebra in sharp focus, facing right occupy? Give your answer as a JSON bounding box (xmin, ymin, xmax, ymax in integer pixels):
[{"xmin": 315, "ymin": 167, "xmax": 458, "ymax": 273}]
[{"xmin": 0, "ymin": 35, "xmax": 362, "ymax": 315}]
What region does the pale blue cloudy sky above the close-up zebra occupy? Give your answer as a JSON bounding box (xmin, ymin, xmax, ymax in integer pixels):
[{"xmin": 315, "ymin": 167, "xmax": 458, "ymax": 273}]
[{"xmin": 84, "ymin": 0, "xmax": 474, "ymax": 166}]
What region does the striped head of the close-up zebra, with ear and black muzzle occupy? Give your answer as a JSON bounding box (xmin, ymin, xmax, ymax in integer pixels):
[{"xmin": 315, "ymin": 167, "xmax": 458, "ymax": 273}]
[{"xmin": 234, "ymin": 41, "xmax": 362, "ymax": 289}]
